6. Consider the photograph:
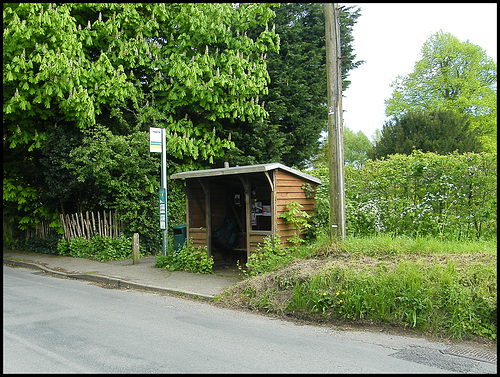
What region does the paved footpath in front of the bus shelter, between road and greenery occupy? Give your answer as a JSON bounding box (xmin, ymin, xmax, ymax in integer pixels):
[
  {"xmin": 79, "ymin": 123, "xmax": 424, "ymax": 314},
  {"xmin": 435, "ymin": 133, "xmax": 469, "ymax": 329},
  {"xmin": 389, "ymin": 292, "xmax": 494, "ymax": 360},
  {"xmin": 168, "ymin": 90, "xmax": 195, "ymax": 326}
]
[{"xmin": 3, "ymin": 248, "xmax": 242, "ymax": 298}]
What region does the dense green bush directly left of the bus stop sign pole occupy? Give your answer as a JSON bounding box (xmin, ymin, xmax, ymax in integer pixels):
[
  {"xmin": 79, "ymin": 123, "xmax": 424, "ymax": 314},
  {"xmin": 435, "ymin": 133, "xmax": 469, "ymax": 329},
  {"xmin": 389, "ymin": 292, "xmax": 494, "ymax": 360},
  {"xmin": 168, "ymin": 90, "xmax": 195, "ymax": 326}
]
[{"xmin": 63, "ymin": 125, "xmax": 161, "ymax": 252}]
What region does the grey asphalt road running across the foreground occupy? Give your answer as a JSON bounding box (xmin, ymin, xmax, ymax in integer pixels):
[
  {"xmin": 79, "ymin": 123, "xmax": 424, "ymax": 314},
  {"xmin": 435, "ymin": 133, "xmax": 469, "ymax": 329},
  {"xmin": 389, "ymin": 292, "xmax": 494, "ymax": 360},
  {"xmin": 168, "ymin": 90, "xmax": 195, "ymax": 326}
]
[{"xmin": 3, "ymin": 266, "xmax": 497, "ymax": 373}]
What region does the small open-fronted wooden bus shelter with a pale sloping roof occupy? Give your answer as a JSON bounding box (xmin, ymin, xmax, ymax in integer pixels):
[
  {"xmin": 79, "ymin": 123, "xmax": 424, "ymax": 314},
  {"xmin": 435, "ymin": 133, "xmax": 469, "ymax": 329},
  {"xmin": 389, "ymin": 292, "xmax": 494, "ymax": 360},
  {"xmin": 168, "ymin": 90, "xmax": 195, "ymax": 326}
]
[{"xmin": 170, "ymin": 163, "xmax": 321, "ymax": 263}]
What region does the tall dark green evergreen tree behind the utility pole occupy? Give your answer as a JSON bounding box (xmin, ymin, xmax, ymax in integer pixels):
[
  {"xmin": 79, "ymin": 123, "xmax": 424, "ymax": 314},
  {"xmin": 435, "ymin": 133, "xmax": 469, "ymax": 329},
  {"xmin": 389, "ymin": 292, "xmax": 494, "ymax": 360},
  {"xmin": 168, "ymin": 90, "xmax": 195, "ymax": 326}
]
[{"xmin": 216, "ymin": 3, "xmax": 362, "ymax": 166}]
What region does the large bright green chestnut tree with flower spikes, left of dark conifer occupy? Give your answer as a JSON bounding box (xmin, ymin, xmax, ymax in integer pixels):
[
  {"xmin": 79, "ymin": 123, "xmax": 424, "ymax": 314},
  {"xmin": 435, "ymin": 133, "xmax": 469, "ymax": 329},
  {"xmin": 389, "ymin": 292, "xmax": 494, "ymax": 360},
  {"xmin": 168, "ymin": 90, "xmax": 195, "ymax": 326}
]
[{"xmin": 3, "ymin": 3, "xmax": 279, "ymax": 232}]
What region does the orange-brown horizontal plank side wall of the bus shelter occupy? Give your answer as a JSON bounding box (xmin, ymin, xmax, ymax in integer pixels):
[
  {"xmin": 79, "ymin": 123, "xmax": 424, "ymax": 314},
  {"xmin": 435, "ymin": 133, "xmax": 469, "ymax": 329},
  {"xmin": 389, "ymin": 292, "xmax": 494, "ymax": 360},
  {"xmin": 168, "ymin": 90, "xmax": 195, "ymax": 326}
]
[{"xmin": 276, "ymin": 170, "xmax": 316, "ymax": 246}]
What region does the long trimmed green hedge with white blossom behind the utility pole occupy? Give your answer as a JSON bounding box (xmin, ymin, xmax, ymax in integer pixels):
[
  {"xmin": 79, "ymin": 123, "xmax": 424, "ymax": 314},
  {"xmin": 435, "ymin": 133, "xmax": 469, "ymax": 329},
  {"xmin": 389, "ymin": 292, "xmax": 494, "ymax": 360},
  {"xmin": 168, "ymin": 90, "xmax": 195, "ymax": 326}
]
[{"xmin": 310, "ymin": 151, "xmax": 497, "ymax": 240}]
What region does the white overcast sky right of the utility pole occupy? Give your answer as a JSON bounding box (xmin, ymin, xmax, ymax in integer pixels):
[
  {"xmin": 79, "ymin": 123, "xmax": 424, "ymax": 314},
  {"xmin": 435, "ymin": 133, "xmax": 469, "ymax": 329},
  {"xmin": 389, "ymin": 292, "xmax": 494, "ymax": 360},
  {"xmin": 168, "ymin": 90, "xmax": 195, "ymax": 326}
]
[{"xmin": 339, "ymin": 3, "xmax": 498, "ymax": 140}]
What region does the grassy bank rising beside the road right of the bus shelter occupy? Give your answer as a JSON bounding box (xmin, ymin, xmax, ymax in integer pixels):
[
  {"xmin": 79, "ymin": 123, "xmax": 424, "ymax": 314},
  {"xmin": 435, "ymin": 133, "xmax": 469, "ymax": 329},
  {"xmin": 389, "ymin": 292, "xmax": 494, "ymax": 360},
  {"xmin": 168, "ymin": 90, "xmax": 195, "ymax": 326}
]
[{"xmin": 221, "ymin": 235, "xmax": 497, "ymax": 341}]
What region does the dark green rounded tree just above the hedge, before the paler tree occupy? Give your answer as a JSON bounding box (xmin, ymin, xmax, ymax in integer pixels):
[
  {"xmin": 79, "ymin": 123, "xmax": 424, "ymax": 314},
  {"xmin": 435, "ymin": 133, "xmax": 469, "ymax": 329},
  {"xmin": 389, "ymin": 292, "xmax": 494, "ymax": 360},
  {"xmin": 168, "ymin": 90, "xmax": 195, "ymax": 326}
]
[{"xmin": 370, "ymin": 110, "xmax": 480, "ymax": 158}]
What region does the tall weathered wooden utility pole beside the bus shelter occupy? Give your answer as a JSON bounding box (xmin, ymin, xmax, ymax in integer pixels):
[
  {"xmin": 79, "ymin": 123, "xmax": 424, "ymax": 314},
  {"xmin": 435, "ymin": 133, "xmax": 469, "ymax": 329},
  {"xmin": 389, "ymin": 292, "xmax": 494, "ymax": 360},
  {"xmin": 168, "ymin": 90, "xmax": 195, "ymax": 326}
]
[{"xmin": 324, "ymin": 3, "xmax": 345, "ymax": 243}]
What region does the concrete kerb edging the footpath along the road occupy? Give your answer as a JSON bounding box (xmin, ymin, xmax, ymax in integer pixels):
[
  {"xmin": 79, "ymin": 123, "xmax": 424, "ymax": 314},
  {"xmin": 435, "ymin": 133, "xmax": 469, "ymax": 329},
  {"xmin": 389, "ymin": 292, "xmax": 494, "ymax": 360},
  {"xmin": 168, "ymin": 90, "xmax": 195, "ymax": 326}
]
[{"xmin": 3, "ymin": 259, "xmax": 215, "ymax": 299}]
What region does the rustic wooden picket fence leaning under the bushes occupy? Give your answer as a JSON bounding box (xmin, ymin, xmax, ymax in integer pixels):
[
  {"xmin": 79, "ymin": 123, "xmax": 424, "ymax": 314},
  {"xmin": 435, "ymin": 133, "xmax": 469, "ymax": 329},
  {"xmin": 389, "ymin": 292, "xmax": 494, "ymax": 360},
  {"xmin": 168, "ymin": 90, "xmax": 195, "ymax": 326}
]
[{"xmin": 60, "ymin": 211, "xmax": 124, "ymax": 242}]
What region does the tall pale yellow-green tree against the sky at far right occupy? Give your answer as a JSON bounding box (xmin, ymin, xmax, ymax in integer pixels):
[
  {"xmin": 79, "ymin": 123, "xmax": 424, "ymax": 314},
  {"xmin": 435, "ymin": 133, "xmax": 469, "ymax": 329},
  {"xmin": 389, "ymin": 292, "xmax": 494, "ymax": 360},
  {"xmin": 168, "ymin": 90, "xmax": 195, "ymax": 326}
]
[{"xmin": 386, "ymin": 31, "xmax": 497, "ymax": 151}]
